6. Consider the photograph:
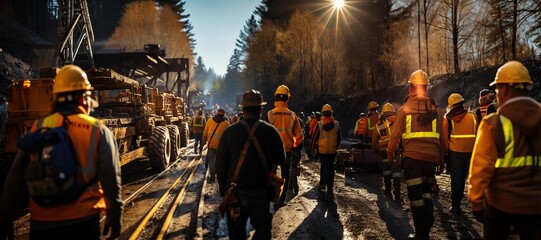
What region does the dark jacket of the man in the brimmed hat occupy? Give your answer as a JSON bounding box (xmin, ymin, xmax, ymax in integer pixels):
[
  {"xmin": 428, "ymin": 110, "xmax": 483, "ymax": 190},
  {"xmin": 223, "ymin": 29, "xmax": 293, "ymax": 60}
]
[{"xmin": 216, "ymin": 119, "xmax": 286, "ymax": 196}]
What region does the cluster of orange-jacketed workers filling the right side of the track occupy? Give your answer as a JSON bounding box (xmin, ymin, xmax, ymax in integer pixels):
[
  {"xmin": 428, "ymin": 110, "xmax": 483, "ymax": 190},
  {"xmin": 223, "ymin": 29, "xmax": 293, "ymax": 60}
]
[{"xmin": 354, "ymin": 61, "xmax": 541, "ymax": 239}]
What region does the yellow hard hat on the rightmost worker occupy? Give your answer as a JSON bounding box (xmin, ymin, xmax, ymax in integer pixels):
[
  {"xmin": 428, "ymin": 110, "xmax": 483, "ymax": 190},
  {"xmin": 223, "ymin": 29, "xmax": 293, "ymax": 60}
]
[{"xmin": 490, "ymin": 61, "xmax": 533, "ymax": 86}]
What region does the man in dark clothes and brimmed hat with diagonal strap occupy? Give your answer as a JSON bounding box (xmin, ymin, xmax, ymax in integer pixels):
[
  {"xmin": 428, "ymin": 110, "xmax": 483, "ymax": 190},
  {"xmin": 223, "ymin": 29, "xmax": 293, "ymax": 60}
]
[{"xmin": 216, "ymin": 90, "xmax": 285, "ymax": 240}]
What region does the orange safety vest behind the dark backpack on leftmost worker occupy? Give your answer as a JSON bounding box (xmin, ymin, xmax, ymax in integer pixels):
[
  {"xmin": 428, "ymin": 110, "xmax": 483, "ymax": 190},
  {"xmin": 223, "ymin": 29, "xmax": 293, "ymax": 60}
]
[{"xmin": 30, "ymin": 113, "xmax": 106, "ymax": 221}]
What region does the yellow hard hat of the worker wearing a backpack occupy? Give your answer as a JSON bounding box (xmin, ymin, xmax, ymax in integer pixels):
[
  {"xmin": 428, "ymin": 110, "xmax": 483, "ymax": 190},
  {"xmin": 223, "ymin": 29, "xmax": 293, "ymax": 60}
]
[{"xmin": 53, "ymin": 65, "xmax": 94, "ymax": 94}]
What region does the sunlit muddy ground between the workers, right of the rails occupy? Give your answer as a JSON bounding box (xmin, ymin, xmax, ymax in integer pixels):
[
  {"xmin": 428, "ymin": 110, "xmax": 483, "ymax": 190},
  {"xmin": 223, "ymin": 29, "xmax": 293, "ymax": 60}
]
[{"xmin": 200, "ymin": 150, "xmax": 482, "ymax": 239}]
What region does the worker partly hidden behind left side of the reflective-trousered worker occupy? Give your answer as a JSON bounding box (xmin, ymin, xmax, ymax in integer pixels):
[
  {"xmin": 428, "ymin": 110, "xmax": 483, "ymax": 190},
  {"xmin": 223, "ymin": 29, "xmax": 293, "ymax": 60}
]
[{"xmin": 372, "ymin": 103, "xmax": 402, "ymax": 202}]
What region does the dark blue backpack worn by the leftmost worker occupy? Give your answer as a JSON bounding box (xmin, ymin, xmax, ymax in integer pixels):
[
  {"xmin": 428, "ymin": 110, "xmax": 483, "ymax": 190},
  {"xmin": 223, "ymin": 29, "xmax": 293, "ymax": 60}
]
[{"xmin": 17, "ymin": 116, "xmax": 96, "ymax": 207}]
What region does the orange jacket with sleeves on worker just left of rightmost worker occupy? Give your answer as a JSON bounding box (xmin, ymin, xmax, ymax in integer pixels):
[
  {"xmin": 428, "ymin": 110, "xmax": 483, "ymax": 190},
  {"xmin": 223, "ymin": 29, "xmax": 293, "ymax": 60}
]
[{"xmin": 443, "ymin": 112, "xmax": 477, "ymax": 153}]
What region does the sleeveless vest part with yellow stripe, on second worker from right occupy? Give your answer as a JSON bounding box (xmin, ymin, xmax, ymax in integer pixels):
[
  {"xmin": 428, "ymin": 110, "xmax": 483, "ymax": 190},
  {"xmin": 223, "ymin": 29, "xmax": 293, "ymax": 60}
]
[{"xmin": 449, "ymin": 113, "xmax": 477, "ymax": 152}]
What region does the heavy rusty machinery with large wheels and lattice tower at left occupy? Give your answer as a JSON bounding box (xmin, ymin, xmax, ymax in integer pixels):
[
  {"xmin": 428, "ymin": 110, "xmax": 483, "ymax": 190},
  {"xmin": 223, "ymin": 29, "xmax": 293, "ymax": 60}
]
[{"xmin": 3, "ymin": 0, "xmax": 189, "ymax": 171}]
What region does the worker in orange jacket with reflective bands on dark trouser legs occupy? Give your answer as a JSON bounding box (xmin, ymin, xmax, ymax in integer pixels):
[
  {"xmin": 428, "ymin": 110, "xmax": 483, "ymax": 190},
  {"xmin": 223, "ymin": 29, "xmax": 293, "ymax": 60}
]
[{"xmin": 387, "ymin": 70, "xmax": 445, "ymax": 239}]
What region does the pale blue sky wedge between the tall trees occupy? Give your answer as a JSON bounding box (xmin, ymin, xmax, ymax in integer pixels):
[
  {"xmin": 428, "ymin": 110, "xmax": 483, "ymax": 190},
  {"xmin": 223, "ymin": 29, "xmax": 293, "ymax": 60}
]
[{"xmin": 185, "ymin": 0, "xmax": 261, "ymax": 75}]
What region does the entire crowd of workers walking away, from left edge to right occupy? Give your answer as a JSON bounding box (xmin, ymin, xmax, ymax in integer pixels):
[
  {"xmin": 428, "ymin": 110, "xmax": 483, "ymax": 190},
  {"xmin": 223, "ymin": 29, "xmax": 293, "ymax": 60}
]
[{"xmin": 0, "ymin": 61, "xmax": 541, "ymax": 239}]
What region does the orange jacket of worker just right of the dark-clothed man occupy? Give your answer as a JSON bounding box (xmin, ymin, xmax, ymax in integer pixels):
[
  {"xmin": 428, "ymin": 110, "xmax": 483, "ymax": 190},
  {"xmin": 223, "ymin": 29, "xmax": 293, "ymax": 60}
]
[{"xmin": 267, "ymin": 101, "xmax": 304, "ymax": 152}]
